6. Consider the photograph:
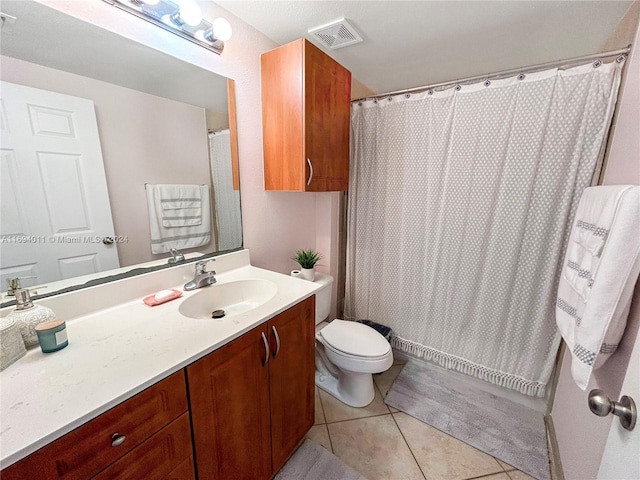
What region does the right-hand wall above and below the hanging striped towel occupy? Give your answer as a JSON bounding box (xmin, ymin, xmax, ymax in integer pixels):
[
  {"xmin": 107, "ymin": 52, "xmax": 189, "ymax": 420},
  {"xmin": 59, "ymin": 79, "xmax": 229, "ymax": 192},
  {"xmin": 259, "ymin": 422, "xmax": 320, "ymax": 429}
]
[{"xmin": 551, "ymin": 9, "xmax": 640, "ymax": 480}]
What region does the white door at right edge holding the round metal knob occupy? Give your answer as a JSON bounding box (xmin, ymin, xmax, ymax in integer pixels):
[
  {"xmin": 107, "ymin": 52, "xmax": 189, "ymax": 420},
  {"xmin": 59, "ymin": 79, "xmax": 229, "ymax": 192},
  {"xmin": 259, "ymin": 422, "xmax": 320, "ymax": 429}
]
[{"xmin": 598, "ymin": 335, "xmax": 640, "ymax": 480}]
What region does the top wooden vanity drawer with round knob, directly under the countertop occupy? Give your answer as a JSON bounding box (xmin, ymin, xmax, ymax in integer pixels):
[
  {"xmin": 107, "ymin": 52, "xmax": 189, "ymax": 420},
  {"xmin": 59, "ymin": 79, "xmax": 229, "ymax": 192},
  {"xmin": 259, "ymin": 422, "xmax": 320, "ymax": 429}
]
[{"xmin": 2, "ymin": 370, "xmax": 187, "ymax": 480}]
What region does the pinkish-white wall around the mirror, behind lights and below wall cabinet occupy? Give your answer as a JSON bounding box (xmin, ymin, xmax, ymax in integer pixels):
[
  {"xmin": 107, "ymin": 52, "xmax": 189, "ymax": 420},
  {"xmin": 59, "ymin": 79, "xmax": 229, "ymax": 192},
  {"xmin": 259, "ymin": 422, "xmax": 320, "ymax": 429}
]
[{"xmin": 32, "ymin": 0, "xmax": 324, "ymax": 280}]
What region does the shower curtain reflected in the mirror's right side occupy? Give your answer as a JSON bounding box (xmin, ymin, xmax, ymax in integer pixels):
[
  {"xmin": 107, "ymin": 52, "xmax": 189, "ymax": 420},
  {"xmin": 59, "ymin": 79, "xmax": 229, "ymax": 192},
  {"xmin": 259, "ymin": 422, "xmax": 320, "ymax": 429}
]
[{"xmin": 209, "ymin": 130, "xmax": 242, "ymax": 251}]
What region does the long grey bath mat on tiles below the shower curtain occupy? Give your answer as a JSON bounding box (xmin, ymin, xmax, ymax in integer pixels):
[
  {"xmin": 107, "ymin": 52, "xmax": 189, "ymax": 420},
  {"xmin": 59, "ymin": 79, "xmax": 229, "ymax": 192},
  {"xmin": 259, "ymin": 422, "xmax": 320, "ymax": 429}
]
[{"xmin": 385, "ymin": 360, "xmax": 551, "ymax": 480}]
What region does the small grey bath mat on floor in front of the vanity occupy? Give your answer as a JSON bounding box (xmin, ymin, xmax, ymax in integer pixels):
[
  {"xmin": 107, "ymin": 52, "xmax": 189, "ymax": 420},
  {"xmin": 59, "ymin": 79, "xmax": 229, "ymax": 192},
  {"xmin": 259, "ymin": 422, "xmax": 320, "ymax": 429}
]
[{"xmin": 274, "ymin": 440, "xmax": 367, "ymax": 480}]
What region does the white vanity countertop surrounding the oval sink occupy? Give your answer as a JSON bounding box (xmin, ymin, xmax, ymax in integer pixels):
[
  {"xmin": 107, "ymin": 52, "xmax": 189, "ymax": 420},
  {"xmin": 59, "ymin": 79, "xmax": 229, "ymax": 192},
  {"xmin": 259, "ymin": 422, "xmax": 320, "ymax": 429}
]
[{"xmin": 0, "ymin": 251, "xmax": 320, "ymax": 468}]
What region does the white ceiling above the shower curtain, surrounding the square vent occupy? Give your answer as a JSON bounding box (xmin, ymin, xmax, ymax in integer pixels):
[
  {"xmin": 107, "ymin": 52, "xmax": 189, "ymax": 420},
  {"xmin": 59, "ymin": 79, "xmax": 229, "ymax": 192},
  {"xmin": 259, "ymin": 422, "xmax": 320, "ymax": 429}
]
[{"xmin": 215, "ymin": 0, "xmax": 633, "ymax": 93}]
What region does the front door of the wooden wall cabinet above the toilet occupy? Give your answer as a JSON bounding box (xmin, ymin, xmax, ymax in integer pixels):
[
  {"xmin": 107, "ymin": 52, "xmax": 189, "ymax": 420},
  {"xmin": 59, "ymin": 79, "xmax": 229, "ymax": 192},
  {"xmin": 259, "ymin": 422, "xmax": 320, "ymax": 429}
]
[{"xmin": 304, "ymin": 41, "xmax": 351, "ymax": 192}]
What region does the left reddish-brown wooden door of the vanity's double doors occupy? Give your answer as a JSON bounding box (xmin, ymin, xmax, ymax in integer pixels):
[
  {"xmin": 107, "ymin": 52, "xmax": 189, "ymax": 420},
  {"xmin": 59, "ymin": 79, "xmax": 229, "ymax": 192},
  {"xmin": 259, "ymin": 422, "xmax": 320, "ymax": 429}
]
[{"xmin": 187, "ymin": 325, "xmax": 272, "ymax": 480}]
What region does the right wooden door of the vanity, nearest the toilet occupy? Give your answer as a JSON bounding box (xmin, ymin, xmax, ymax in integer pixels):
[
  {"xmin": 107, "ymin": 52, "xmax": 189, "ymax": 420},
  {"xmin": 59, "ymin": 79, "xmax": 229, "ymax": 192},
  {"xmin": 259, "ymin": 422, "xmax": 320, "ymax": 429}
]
[{"xmin": 268, "ymin": 296, "xmax": 315, "ymax": 472}]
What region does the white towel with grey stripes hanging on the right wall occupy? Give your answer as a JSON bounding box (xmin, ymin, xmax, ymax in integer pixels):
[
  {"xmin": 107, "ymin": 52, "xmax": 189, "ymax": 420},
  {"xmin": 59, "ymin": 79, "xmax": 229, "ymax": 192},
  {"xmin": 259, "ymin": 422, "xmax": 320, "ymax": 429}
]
[{"xmin": 556, "ymin": 185, "xmax": 640, "ymax": 390}]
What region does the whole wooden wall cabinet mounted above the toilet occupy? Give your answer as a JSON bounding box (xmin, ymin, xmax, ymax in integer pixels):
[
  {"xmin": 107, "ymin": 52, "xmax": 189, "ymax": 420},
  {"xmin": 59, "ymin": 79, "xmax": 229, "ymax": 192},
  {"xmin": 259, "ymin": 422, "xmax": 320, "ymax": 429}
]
[{"xmin": 261, "ymin": 39, "xmax": 351, "ymax": 192}]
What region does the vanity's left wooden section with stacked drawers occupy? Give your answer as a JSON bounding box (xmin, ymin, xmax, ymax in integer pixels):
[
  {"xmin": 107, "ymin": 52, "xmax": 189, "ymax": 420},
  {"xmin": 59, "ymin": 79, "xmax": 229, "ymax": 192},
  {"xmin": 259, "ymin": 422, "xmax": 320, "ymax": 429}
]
[{"xmin": 0, "ymin": 371, "xmax": 195, "ymax": 480}]
